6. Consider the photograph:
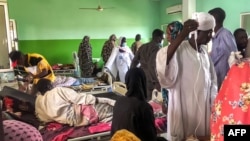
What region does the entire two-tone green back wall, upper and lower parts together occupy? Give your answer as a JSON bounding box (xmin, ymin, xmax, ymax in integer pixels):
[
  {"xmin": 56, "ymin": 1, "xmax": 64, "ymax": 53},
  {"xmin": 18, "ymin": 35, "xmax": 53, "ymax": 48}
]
[{"xmin": 7, "ymin": 0, "xmax": 160, "ymax": 64}]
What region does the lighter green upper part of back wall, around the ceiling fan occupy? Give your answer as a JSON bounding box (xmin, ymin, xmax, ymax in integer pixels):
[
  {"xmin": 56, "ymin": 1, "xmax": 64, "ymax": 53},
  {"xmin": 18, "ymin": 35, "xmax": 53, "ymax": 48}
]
[{"xmin": 8, "ymin": 0, "xmax": 159, "ymax": 40}]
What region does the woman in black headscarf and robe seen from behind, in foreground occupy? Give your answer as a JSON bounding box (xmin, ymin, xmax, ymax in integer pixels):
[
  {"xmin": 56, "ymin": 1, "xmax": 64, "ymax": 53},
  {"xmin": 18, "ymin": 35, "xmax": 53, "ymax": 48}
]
[{"xmin": 111, "ymin": 68, "xmax": 157, "ymax": 141}]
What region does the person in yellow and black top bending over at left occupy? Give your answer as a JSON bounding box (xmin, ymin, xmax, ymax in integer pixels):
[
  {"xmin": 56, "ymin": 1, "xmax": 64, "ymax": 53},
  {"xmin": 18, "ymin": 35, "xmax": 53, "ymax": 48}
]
[{"xmin": 9, "ymin": 51, "xmax": 55, "ymax": 94}]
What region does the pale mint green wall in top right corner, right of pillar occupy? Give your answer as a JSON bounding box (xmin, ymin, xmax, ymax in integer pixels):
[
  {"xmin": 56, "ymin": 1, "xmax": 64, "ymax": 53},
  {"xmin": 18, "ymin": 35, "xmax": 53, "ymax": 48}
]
[{"xmin": 196, "ymin": 0, "xmax": 250, "ymax": 32}]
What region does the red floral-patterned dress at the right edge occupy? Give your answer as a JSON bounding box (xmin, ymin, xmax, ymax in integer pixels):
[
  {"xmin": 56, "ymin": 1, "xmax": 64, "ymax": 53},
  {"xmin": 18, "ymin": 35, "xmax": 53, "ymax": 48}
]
[{"xmin": 211, "ymin": 60, "xmax": 250, "ymax": 141}]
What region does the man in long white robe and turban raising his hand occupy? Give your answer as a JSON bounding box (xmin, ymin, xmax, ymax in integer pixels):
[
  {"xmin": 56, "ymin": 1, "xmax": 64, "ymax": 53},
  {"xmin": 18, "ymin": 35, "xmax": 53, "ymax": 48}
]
[{"xmin": 156, "ymin": 13, "xmax": 217, "ymax": 141}]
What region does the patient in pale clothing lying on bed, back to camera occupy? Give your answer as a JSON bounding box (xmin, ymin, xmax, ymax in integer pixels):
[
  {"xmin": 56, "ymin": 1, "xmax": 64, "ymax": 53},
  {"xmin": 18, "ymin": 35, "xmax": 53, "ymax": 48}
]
[{"xmin": 35, "ymin": 79, "xmax": 115, "ymax": 126}]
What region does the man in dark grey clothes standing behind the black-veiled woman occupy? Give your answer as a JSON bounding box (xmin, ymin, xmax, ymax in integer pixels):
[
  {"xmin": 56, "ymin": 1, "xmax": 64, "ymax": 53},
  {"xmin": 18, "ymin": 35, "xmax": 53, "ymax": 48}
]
[{"xmin": 131, "ymin": 29, "xmax": 164, "ymax": 100}]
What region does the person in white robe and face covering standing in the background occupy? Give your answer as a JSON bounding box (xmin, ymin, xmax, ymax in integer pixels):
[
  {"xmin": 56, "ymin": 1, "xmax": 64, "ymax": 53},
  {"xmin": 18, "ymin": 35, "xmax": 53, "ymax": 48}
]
[{"xmin": 115, "ymin": 37, "xmax": 134, "ymax": 83}]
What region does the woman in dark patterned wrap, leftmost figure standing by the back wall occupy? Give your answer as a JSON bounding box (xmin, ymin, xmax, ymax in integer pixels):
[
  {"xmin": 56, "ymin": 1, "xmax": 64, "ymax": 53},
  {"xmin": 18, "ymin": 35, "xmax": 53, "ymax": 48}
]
[{"xmin": 78, "ymin": 36, "xmax": 93, "ymax": 77}]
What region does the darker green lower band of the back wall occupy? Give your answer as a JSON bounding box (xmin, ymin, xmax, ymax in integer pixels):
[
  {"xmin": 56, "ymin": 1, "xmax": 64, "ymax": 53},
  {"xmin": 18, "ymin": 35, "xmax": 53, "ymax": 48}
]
[{"xmin": 19, "ymin": 39, "xmax": 137, "ymax": 66}]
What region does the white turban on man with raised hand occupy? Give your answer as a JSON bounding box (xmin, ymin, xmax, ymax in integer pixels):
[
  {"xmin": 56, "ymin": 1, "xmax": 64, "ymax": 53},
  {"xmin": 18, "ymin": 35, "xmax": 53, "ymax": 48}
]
[{"xmin": 193, "ymin": 12, "xmax": 215, "ymax": 31}]
